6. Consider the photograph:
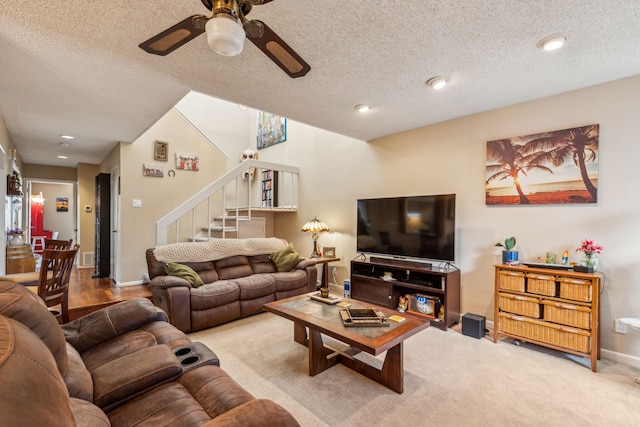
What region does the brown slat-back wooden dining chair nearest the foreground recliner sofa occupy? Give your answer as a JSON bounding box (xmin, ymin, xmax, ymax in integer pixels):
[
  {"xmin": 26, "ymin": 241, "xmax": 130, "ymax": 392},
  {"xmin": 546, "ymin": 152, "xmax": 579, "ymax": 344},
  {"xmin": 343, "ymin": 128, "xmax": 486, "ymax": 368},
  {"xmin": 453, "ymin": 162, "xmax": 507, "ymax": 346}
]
[{"xmin": 29, "ymin": 245, "xmax": 80, "ymax": 323}]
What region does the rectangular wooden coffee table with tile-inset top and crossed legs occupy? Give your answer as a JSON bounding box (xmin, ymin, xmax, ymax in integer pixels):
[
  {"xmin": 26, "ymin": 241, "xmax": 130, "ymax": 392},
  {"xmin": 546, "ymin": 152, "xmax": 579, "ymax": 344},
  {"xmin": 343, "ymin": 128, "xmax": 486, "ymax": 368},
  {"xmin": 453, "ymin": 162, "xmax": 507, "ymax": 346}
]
[{"xmin": 264, "ymin": 292, "xmax": 429, "ymax": 393}]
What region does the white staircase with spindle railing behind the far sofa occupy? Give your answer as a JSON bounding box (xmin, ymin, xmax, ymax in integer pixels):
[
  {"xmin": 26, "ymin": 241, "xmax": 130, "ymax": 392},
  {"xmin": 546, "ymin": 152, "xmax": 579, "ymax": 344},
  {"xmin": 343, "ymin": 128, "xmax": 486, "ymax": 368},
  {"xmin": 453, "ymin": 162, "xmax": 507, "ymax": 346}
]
[{"xmin": 156, "ymin": 159, "xmax": 299, "ymax": 245}]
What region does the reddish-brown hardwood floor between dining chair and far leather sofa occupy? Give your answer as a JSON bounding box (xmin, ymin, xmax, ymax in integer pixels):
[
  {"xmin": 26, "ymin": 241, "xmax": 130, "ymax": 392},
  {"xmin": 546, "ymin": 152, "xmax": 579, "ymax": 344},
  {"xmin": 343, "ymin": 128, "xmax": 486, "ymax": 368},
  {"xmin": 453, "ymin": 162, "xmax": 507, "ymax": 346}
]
[{"xmin": 69, "ymin": 268, "xmax": 151, "ymax": 320}]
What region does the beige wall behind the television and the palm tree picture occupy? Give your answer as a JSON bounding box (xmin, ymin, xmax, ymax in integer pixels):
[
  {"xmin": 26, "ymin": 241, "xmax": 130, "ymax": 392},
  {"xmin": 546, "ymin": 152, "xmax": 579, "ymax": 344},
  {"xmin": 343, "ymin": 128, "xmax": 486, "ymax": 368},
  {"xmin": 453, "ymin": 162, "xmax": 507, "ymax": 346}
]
[{"xmin": 252, "ymin": 76, "xmax": 640, "ymax": 362}]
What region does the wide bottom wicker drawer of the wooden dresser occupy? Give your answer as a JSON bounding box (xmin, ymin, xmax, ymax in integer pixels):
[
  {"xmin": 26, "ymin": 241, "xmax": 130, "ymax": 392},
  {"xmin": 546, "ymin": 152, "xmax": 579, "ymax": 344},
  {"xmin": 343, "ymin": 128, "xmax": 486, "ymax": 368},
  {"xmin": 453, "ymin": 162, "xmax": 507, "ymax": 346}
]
[{"xmin": 499, "ymin": 313, "xmax": 591, "ymax": 353}]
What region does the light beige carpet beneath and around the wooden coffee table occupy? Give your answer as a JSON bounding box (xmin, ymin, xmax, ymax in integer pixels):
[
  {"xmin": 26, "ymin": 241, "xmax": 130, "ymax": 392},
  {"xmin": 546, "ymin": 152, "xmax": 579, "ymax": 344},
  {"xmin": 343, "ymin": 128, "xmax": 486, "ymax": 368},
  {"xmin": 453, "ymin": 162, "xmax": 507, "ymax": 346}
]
[{"xmin": 190, "ymin": 313, "xmax": 640, "ymax": 427}]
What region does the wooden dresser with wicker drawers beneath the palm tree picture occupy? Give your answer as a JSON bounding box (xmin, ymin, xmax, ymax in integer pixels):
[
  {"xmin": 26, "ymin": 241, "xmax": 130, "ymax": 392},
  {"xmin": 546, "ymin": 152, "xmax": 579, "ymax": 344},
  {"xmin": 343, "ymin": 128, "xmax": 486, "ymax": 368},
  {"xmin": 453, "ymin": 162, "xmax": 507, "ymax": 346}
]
[{"xmin": 493, "ymin": 265, "xmax": 601, "ymax": 372}]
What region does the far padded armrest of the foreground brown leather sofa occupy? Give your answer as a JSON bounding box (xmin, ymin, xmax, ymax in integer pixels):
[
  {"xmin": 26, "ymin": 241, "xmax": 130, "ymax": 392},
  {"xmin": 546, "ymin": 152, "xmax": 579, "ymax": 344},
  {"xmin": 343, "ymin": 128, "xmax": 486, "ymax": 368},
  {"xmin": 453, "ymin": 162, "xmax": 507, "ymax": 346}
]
[{"xmin": 62, "ymin": 298, "xmax": 164, "ymax": 353}]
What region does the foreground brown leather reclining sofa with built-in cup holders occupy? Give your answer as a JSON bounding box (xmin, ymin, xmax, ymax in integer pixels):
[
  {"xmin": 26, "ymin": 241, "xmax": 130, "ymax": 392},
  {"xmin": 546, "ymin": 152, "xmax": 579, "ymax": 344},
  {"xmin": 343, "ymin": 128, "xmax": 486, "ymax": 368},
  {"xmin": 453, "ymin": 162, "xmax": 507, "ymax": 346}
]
[{"xmin": 0, "ymin": 282, "xmax": 298, "ymax": 426}]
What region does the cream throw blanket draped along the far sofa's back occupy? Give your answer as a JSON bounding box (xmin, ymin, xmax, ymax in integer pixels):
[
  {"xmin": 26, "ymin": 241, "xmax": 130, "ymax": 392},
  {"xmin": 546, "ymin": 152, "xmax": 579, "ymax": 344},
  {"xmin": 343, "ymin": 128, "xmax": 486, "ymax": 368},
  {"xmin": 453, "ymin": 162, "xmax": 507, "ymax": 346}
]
[{"xmin": 153, "ymin": 237, "xmax": 287, "ymax": 262}]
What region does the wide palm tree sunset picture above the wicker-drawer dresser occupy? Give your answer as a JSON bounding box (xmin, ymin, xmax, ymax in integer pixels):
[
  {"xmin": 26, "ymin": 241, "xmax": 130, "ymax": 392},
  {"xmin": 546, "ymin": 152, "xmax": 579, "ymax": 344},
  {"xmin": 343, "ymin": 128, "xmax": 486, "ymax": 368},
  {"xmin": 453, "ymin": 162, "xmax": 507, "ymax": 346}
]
[{"xmin": 485, "ymin": 124, "xmax": 599, "ymax": 205}]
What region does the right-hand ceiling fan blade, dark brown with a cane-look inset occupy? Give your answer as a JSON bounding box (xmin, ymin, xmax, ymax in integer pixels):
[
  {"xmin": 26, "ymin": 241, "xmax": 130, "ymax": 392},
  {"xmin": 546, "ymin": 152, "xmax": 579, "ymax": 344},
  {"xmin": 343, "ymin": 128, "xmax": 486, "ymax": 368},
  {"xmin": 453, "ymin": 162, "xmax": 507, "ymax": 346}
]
[{"xmin": 244, "ymin": 20, "xmax": 311, "ymax": 78}]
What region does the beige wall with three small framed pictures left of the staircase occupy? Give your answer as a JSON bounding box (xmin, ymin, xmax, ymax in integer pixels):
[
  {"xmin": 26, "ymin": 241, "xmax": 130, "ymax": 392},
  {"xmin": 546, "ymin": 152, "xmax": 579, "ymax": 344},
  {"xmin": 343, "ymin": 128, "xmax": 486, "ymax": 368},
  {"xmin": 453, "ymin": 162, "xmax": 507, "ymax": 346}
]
[{"xmin": 116, "ymin": 109, "xmax": 227, "ymax": 283}]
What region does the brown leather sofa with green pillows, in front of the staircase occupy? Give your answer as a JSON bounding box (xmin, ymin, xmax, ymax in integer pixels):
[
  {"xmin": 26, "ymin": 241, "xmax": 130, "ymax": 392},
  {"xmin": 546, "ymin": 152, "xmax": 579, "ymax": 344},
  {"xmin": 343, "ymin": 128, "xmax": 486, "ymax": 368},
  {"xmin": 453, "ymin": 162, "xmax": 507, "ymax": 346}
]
[{"xmin": 146, "ymin": 249, "xmax": 318, "ymax": 332}]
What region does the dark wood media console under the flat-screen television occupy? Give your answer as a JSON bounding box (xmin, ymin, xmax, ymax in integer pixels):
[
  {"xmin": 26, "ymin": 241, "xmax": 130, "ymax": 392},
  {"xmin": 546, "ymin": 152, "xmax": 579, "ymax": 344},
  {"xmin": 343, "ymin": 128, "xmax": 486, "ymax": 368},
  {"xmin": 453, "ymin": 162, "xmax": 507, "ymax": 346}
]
[{"xmin": 351, "ymin": 257, "xmax": 460, "ymax": 330}]
